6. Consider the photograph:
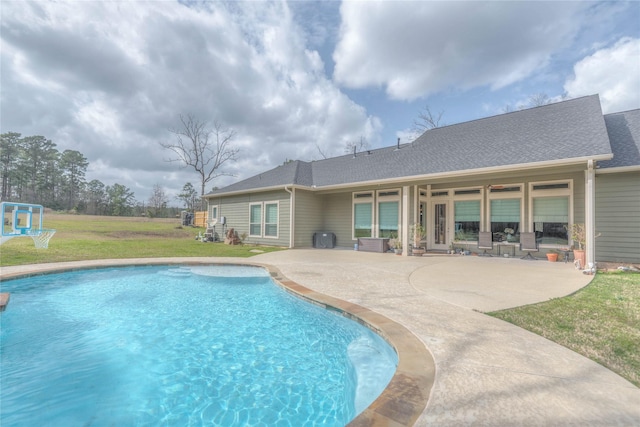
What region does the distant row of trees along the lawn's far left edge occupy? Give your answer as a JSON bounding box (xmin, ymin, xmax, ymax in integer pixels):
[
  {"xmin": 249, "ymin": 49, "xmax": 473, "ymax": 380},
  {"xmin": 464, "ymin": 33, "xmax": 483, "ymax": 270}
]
[{"xmin": 0, "ymin": 132, "xmax": 199, "ymax": 217}]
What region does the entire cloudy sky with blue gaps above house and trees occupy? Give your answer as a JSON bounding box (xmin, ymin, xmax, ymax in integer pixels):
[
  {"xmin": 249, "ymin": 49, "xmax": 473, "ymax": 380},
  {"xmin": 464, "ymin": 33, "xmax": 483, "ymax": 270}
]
[{"xmin": 0, "ymin": 0, "xmax": 640, "ymax": 201}]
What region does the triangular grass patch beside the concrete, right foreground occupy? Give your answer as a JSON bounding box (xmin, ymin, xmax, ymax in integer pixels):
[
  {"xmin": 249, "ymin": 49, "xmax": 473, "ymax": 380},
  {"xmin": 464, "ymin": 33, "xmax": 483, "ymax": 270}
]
[{"xmin": 488, "ymin": 272, "xmax": 640, "ymax": 386}]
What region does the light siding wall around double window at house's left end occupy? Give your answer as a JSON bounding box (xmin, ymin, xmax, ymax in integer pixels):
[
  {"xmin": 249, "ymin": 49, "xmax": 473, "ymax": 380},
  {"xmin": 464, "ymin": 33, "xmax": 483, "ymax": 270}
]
[{"xmin": 209, "ymin": 190, "xmax": 290, "ymax": 247}]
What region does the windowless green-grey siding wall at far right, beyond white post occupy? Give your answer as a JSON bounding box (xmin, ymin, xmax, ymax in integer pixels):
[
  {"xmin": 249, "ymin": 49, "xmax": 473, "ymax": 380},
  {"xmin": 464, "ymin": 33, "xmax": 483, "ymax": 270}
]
[{"xmin": 595, "ymin": 172, "xmax": 640, "ymax": 263}]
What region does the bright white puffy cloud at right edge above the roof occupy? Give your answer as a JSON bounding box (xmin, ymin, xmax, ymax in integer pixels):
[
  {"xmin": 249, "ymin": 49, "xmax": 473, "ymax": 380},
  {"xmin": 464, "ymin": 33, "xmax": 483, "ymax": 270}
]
[{"xmin": 564, "ymin": 37, "xmax": 640, "ymax": 114}]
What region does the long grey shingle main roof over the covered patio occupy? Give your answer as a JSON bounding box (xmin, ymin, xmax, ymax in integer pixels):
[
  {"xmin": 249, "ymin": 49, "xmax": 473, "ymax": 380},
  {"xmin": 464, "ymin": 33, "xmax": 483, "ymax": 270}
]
[{"xmin": 205, "ymin": 95, "xmax": 612, "ymax": 197}]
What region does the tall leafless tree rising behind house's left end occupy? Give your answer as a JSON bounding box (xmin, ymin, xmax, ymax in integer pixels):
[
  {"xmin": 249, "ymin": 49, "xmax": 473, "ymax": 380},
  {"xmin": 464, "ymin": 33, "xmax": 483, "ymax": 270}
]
[{"xmin": 161, "ymin": 114, "xmax": 240, "ymax": 209}]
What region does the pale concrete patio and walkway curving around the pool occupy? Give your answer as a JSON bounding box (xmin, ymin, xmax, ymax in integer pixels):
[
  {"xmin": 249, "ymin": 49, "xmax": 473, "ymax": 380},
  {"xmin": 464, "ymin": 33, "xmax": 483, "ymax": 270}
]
[{"xmin": 1, "ymin": 249, "xmax": 640, "ymax": 426}]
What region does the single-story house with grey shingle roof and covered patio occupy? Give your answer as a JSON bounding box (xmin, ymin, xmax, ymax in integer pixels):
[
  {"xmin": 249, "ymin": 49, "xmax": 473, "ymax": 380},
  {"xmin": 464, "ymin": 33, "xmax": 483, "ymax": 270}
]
[{"xmin": 205, "ymin": 95, "xmax": 640, "ymax": 262}]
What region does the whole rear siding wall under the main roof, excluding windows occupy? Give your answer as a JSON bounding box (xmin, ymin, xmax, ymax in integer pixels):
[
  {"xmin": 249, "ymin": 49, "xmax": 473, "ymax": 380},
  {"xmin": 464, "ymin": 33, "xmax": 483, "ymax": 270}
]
[{"xmin": 209, "ymin": 164, "xmax": 598, "ymax": 254}]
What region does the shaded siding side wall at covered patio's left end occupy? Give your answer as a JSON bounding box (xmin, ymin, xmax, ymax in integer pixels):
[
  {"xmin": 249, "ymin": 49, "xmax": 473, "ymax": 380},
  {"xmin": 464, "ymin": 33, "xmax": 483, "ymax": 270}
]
[{"xmin": 294, "ymin": 189, "xmax": 324, "ymax": 248}]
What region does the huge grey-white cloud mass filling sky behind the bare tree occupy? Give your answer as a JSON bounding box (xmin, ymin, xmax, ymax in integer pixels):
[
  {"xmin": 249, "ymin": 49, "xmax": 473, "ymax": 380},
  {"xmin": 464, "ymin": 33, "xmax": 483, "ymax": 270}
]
[{"xmin": 1, "ymin": 1, "xmax": 381, "ymax": 200}]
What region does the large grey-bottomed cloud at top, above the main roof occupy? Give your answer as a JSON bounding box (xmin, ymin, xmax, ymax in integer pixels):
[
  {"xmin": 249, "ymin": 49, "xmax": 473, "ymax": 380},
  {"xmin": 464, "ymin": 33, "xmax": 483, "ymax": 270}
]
[{"xmin": 334, "ymin": 1, "xmax": 588, "ymax": 100}]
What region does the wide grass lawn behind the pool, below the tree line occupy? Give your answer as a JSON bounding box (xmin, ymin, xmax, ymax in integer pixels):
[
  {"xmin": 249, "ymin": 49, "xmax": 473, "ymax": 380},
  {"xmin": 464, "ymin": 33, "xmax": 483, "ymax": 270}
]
[{"xmin": 0, "ymin": 213, "xmax": 280, "ymax": 267}]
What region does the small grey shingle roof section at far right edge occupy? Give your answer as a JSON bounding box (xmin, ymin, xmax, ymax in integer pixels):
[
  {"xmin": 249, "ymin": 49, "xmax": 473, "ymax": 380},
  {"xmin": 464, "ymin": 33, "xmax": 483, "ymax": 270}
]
[{"xmin": 598, "ymin": 110, "xmax": 640, "ymax": 169}]
